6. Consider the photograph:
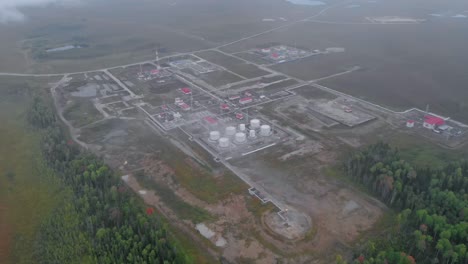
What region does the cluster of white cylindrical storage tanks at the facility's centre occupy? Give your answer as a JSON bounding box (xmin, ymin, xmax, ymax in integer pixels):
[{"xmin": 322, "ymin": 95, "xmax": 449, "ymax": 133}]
[{"xmin": 209, "ymin": 119, "xmax": 272, "ymax": 148}]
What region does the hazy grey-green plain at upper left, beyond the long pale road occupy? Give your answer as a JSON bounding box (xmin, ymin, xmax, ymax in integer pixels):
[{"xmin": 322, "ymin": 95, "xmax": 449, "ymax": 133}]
[{"xmin": 0, "ymin": 0, "xmax": 324, "ymax": 72}]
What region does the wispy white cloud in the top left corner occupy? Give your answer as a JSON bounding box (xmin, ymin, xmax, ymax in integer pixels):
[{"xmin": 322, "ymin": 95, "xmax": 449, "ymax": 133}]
[{"xmin": 0, "ymin": 0, "xmax": 79, "ymax": 23}]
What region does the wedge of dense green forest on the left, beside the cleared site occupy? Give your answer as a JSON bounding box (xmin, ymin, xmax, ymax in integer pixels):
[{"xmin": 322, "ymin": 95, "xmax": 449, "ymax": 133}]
[{"xmin": 27, "ymin": 96, "xmax": 188, "ymax": 264}]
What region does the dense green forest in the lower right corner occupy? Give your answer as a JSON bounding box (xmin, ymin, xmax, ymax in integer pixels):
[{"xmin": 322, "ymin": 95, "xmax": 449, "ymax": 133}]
[{"xmin": 344, "ymin": 143, "xmax": 468, "ymax": 264}]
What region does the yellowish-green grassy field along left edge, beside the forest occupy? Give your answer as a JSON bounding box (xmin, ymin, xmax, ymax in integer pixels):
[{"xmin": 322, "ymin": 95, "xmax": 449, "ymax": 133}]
[{"xmin": 0, "ymin": 78, "xmax": 64, "ymax": 263}]
